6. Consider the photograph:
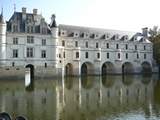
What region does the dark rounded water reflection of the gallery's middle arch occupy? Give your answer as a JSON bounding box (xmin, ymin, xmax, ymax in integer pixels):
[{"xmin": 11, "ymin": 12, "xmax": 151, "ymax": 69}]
[{"xmin": 102, "ymin": 75, "xmax": 115, "ymax": 88}]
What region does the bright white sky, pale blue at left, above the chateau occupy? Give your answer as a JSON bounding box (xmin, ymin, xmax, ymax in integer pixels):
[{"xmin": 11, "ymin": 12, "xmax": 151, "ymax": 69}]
[{"xmin": 0, "ymin": 0, "xmax": 160, "ymax": 32}]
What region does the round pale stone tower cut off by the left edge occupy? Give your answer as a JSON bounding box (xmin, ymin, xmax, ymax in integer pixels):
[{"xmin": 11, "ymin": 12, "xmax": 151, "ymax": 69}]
[{"xmin": 0, "ymin": 9, "xmax": 6, "ymax": 66}]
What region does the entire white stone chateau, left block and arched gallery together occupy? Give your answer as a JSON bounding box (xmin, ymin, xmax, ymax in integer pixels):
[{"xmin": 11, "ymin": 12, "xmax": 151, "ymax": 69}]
[{"xmin": 0, "ymin": 7, "xmax": 154, "ymax": 79}]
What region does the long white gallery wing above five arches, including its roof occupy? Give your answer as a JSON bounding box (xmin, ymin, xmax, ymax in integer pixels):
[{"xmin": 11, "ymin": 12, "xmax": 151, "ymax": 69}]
[{"xmin": 59, "ymin": 25, "xmax": 153, "ymax": 75}]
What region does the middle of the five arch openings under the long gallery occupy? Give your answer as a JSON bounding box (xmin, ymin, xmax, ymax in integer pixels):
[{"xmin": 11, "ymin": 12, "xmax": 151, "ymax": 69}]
[{"xmin": 102, "ymin": 62, "xmax": 114, "ymax": 75}]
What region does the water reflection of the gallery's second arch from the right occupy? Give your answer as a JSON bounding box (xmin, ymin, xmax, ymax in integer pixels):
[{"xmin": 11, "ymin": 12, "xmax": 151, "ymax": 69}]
[{"xmin": 122, "ymin": 75, "xmax": 134, "ymax": 86}]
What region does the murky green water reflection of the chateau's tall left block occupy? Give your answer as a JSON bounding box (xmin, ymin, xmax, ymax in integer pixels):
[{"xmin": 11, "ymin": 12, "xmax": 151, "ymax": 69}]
[{"xmin": 0, "ymin": 80, "xmax": 57, "ymax": 120}]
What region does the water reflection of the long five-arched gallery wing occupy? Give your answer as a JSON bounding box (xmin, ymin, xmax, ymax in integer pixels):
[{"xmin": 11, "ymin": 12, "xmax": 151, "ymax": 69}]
[{"xmin": 60, "ymin": 76, "xmax": 154, "ymax": 120}]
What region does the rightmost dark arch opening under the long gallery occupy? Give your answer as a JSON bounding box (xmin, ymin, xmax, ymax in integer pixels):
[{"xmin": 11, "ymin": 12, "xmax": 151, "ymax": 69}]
[{"xmin": 141, "ymin": 61, "xmax": 152, "ymax": 74}]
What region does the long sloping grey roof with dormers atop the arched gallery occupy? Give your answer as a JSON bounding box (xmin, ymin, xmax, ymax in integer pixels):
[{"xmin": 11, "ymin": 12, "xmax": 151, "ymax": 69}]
[{"xmin": 58, "ymin": 24, "xmax": 151, "ymax": 43}]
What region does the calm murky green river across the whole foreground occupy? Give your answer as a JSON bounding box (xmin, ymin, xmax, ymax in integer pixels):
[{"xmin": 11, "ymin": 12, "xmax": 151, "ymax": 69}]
[{"xmin": 0, "ymin": 75, "xmax": 160, "ymax": 120}]
